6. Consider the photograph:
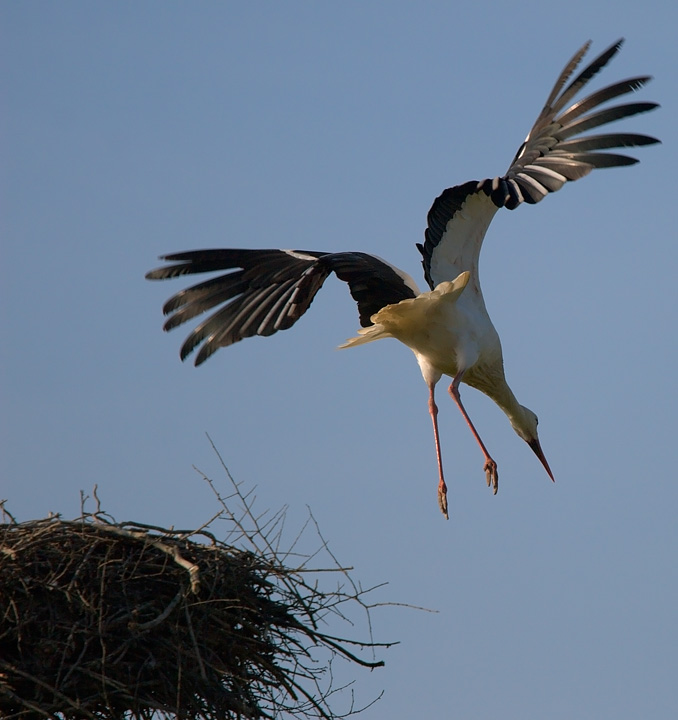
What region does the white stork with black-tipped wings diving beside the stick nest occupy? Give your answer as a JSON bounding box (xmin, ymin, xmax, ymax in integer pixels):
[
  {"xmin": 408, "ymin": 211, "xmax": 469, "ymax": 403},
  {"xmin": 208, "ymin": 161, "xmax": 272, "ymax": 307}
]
[{"xmin": 146, "ymin": 38, "xmax": 660, "ymax": 518}]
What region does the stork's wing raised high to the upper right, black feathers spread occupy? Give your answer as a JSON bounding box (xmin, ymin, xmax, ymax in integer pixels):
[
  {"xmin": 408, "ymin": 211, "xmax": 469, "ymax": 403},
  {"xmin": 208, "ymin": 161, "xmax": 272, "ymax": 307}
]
[{"xmin": 417, "ymin": 39, "xmax": 659, "ymax": 288}]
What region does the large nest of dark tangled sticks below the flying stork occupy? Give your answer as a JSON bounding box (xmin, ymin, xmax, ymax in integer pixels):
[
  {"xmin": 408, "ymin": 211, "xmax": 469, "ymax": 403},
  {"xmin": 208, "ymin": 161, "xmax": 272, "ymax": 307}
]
[{"xmin": 0, "ymin": 472, "xmax": 394, "ymax": 720}]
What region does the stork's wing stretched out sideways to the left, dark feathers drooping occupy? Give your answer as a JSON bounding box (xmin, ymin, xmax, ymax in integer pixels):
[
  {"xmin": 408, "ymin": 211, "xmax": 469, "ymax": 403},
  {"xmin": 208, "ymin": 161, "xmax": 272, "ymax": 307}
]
[{"xmin": 146, "ymin": 250, "xmax": 419, "ymax": 365}]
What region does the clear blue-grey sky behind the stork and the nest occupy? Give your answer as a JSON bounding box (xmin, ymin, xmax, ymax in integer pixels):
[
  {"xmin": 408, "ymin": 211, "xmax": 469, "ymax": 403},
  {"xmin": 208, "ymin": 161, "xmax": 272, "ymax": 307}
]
[{"xmin": 0, "ymin": 0, "xmax": 678, "ymax": 720}]
